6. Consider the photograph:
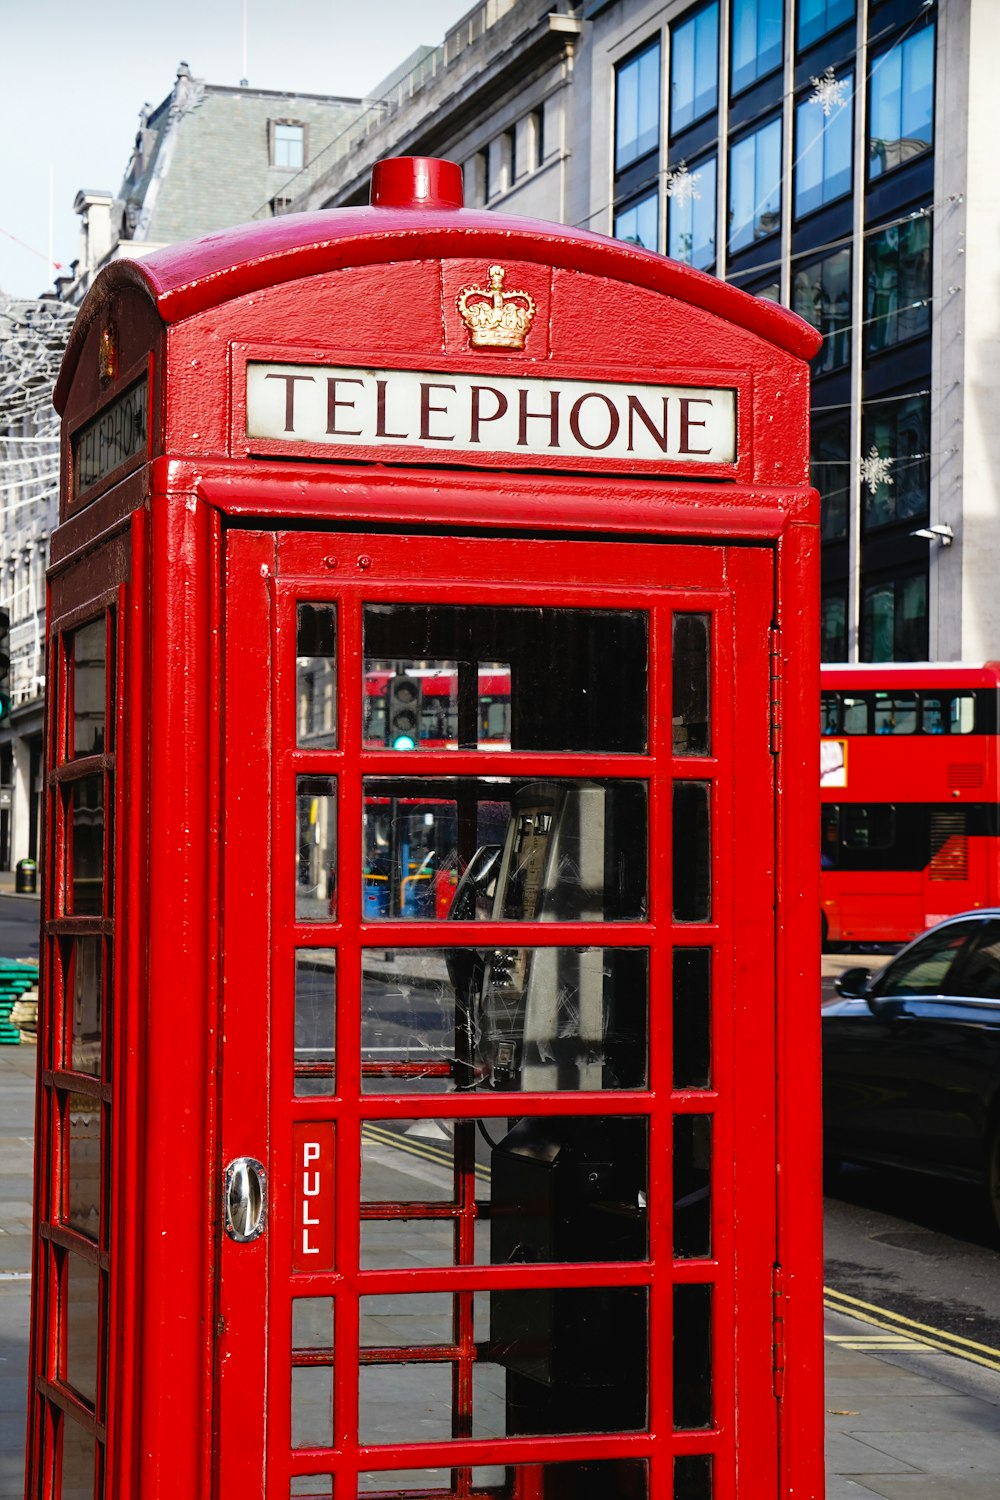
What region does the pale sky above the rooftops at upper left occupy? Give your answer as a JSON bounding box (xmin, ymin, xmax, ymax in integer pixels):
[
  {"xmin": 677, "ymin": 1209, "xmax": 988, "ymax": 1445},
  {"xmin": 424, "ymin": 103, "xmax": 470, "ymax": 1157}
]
[{"xmin": 0, "ymin": 0, "xmax": 475, "ymax": 297}]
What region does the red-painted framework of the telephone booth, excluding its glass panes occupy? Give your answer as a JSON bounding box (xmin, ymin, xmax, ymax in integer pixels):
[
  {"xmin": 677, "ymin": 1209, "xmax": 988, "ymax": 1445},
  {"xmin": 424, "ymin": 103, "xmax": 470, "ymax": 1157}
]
[{"xmin": 28, "ymin": 159, "xmax": 823, "ymax": 1500}]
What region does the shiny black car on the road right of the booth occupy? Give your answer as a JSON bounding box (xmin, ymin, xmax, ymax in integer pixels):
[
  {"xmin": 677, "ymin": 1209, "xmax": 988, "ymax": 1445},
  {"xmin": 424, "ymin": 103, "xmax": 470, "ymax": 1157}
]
[{"xmin": 823, "ymin": 909, "xmax": 1000, "ymax": 1232}]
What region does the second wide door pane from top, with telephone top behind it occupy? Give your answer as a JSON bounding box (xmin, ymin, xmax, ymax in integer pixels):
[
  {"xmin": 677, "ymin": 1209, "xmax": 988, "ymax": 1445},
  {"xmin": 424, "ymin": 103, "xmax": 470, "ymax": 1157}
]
[{"xmin": 363, "ymin": 777, "xmax": 646, "ymax": 921}]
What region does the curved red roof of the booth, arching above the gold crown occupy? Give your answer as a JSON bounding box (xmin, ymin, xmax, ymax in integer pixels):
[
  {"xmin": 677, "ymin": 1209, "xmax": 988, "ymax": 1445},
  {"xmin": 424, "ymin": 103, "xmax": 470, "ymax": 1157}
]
[{"xmin": 54, "ymin": 186, "xmax": 822, "ymax": 413}]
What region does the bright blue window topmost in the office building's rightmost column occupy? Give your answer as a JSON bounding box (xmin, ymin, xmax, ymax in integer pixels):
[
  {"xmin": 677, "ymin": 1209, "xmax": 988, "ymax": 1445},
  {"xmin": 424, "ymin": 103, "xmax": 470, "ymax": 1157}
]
[{"xmin": 868, "ymin": 26, "xmax": 934, "ymax": 179}]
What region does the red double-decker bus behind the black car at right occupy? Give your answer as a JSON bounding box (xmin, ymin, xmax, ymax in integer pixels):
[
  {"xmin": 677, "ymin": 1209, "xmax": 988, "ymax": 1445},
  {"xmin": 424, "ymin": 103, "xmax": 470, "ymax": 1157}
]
[{"xmin": 820, "ymin": 662, "xmax": 1000, "ymax": 944}]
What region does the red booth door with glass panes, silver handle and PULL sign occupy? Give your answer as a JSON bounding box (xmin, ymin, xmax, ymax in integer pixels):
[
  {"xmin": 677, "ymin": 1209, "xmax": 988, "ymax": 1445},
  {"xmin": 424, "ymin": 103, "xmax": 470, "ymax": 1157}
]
[{"xmin": 214, "ymin": 531, "xmax": 778, "ymax": 1500}]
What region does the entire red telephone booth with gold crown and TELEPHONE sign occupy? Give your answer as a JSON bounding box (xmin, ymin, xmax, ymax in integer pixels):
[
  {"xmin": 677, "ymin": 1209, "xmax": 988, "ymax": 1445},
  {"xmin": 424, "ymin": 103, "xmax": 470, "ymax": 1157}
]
[{"xmin": 27, "ymin": 159, "xmax": 822, "ymax": 1500}]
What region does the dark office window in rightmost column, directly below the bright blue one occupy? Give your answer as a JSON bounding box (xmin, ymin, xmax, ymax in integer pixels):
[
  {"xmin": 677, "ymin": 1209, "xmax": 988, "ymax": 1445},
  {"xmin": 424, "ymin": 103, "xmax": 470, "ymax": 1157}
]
[{"xmin": 865, "ymin": 215, "xmax": 931, "ymax": 354}]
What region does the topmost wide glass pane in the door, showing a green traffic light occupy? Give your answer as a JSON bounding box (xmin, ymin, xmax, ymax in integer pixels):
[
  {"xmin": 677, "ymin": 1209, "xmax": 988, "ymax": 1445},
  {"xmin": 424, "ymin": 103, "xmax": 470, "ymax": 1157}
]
[{"xmin": 364, "ymin": 605, "xmax": 648, "ymax": 753}]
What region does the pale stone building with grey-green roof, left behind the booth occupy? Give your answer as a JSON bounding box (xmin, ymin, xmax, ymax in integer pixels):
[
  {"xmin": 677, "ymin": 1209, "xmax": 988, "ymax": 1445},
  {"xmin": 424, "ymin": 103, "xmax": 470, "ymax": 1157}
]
[{"xmin": 0, "ymin": 63, "xmax": 363, "ymax": 870}]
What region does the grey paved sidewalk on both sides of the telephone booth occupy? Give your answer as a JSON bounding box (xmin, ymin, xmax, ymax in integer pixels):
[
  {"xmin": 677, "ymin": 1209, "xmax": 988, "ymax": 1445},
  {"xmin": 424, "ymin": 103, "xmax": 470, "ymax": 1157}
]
[{"xmin": 0, "ymin": 924, "xmax": 1000, "ymax": 1500}]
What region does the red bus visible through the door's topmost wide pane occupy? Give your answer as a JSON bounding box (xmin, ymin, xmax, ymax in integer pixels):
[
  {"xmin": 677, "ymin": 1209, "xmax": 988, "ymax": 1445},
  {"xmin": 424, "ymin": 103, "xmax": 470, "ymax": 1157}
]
[{"xmin": 364, "ymin": 662, "xmax": 510, "ymax": 750}]
